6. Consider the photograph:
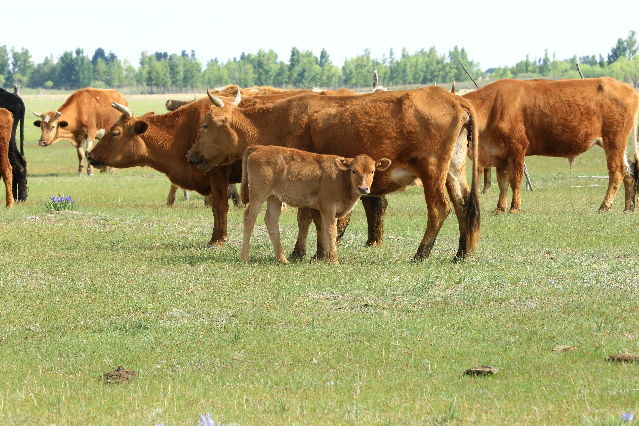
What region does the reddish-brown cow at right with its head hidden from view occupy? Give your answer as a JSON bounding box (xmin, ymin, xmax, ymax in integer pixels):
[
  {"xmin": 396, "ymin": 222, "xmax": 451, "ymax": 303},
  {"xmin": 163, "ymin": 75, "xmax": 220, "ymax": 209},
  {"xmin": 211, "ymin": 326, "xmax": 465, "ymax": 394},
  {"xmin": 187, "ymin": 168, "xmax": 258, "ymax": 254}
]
[{"xmin": 463, "ymin": 77, "xmax": 639, "ymax": 213}]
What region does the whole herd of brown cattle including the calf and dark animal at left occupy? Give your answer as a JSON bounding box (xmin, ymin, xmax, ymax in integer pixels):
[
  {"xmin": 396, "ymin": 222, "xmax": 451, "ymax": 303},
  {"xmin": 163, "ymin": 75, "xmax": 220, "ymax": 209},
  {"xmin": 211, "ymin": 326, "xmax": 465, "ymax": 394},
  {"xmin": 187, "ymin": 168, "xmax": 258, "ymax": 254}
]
[{"xmin": 0, "ymin": 77, "xmax": 639, "ymax": 262}]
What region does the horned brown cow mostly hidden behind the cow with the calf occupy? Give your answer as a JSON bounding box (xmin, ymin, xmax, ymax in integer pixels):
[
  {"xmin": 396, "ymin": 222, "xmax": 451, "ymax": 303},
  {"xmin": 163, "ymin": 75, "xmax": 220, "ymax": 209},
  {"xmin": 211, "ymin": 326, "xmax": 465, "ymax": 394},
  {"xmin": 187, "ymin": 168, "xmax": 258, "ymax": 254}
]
[{"xmin": 87, "ymin": 87, "xmax": 362, "ymax": 253}]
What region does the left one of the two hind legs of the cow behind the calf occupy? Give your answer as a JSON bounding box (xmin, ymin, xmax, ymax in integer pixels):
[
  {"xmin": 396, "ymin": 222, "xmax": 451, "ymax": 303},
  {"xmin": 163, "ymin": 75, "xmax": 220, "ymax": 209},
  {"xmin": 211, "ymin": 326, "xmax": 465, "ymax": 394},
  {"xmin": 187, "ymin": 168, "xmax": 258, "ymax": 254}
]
[{"xmin": 413, "ymin": 170, "xmax": 450, "ymax": 261}]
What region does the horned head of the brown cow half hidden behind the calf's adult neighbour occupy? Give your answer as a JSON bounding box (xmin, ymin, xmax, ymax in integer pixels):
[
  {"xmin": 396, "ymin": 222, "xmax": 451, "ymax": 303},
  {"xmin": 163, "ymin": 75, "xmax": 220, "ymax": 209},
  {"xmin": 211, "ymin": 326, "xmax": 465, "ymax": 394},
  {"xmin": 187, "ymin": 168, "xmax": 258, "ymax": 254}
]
[{"xmin": 87, "ymin": 102, "xmax": 149, "ymax": 168}]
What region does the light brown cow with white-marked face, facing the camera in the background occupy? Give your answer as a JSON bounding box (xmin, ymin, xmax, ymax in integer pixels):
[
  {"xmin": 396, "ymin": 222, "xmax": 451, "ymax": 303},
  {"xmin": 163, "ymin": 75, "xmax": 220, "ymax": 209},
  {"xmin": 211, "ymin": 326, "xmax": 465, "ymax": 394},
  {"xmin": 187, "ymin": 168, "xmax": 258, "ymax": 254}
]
[{"xmin": 33, "ymin": 87, "xmax": 128, "ymax": 176}]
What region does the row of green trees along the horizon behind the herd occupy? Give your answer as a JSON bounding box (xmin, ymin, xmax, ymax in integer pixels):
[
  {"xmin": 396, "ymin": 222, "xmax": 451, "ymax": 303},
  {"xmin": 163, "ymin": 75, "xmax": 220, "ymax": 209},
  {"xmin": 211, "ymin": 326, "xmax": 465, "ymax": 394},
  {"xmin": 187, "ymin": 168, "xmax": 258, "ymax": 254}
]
[{"xmin": 0, "ymin": 31, "xmax": 639, "ymax": 93}]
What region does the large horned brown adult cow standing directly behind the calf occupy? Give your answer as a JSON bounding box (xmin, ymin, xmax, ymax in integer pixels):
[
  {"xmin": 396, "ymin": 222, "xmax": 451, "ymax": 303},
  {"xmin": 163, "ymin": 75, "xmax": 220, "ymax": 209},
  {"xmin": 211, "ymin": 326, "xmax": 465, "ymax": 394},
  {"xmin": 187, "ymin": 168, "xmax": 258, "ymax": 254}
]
[{"xmin": 188, "ymin": 87, "xmax": 480, "ymax": 260}]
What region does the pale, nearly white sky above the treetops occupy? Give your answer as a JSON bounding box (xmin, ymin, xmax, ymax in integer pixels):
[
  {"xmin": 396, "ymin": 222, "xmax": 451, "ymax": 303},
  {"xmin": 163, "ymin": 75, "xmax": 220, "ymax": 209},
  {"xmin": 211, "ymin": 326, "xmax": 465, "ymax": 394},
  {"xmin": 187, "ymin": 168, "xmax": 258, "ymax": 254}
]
[{"xmin": 5, "ymin": 0, "xmax": 639, "ymax": 70}]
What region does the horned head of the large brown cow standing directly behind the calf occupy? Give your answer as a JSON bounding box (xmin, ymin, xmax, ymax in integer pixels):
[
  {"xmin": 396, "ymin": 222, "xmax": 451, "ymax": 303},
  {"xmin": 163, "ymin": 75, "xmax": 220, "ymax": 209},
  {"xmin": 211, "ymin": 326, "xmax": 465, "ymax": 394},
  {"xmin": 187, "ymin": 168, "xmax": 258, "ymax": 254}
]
[{"xmin": 187, "ymin": 87, "xmax": 246, "ymax": 172}]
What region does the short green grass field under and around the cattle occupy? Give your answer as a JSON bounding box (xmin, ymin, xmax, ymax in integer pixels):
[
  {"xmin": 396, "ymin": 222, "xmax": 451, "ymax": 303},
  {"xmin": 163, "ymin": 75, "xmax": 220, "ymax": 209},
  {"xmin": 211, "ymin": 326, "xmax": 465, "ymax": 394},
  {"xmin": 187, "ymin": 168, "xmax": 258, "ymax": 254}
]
[{"xmin": 0, "ymin": 99, "xmax": 639, "ymax": 426}]
